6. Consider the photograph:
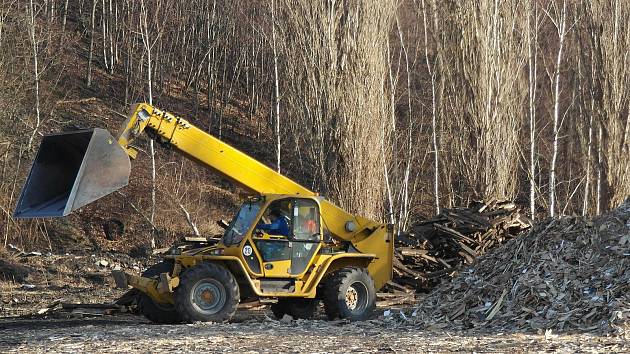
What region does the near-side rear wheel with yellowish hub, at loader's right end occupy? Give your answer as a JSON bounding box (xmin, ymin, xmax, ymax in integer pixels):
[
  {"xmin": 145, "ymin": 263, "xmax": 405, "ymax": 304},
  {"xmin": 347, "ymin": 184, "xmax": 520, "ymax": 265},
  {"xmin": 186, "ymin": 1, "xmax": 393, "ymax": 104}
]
[{"xmin": 323, "ymin": 268, "xmax": 376, "ymax": 321}]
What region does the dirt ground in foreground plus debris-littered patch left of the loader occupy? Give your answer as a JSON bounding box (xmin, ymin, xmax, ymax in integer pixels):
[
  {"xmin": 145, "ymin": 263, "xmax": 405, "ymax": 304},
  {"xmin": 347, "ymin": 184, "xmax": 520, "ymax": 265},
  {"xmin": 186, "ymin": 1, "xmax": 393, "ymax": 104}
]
[{"xmin": 0, "ymin": 253, "xmax": 630, "ymax": 353}]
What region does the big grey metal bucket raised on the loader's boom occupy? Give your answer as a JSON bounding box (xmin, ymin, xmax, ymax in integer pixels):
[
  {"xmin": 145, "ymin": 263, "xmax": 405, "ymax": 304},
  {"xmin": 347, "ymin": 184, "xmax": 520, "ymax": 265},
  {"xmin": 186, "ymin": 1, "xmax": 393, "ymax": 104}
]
[{"xmin": 13, "ymin": 128, "xmax": 131, "ymax": 219}]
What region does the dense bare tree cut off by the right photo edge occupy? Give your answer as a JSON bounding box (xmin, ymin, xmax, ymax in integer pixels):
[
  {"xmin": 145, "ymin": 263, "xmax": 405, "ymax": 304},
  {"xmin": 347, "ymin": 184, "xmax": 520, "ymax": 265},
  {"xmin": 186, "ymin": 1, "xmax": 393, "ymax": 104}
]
[{"xmin": 585, "ymin": 0, "xmax": 630, "ymax": 209}]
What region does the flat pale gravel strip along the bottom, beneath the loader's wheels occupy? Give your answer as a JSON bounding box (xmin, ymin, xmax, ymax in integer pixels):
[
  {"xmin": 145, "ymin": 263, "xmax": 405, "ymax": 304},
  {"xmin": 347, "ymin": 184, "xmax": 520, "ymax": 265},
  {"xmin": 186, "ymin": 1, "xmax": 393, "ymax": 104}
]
[{"xmin": 0, "ymin": 314, "xmax": 630, "ymax": 353}]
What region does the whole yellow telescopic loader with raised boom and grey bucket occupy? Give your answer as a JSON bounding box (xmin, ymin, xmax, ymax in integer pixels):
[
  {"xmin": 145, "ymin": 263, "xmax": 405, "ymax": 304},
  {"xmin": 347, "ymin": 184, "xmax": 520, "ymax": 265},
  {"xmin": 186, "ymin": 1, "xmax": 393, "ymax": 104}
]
[{"xmin": 14, "ymin": 103, "xmax": 394, "ymax": 323}]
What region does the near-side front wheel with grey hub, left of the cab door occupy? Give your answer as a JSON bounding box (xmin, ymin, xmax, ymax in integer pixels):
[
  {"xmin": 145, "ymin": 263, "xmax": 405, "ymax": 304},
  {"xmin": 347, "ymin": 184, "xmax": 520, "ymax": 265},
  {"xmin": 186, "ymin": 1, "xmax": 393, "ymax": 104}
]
[{"xmin": 175, "ymin": 263, "xmax": 240, "ymax": 323}]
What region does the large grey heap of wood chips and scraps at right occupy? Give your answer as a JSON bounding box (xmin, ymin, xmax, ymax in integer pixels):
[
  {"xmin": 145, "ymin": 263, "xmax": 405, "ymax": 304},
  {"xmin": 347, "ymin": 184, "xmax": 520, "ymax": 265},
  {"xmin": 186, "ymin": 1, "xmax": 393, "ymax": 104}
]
[{"xmin": 417, "ymin": 198, "xmax": 630, "ymax": 332}]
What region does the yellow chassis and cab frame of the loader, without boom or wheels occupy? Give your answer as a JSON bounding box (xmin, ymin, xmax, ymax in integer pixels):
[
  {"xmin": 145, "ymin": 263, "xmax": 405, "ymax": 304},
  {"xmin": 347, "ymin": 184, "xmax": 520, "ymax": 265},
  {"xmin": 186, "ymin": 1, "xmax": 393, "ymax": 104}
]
[{"xmin": 115, "ymin": 194, "xmax": 391, "ymax": 303}]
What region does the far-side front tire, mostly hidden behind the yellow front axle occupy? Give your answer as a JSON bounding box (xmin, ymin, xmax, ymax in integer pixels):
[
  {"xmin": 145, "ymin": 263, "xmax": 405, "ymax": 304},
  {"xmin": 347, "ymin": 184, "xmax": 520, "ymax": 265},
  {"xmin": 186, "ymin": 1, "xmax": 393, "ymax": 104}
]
[{"xmin": 138, "ymin": 262, "xmax": 182, "ymax": 324}]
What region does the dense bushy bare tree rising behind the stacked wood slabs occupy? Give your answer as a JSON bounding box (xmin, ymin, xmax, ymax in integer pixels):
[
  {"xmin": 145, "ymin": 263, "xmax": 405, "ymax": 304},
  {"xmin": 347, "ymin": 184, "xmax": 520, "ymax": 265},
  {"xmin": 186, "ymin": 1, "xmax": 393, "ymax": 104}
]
[{"xmin": 438, "ymin": 0, "xmax": 527, "ymax": 203}]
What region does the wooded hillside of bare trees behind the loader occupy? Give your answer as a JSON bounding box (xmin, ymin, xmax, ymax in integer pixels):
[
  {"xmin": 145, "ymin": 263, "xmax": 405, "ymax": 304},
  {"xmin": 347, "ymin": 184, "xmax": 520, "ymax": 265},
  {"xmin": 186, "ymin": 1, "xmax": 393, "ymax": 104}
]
[{"xmin": 0, "ymin": 0, "xmax": 630, "ymax": 249}]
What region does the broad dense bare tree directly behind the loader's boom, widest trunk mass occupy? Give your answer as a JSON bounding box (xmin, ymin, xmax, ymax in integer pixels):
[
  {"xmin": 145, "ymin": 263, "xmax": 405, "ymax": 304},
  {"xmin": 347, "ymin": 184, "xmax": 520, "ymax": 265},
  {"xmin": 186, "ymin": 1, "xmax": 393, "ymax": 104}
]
[{"xmin": 279, "ymin": 0, "xmax": 395, "ymax": 219}]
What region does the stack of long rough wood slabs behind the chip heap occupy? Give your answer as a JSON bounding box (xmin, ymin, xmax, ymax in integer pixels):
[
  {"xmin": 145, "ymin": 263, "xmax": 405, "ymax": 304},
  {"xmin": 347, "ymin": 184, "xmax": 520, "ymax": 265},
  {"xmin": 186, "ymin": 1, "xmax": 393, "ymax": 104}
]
[{"xmin": 389, "ymin": 200, "xmax": 531, "ymax": 297}]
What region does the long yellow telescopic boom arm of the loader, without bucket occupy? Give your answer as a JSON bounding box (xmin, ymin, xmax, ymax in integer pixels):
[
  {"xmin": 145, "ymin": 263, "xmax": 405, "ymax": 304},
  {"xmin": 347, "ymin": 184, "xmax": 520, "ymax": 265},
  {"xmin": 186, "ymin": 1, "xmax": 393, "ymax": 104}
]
[{"xmin": 118, "ymin": 103, "xmax": 383, "ymax": 245}]
